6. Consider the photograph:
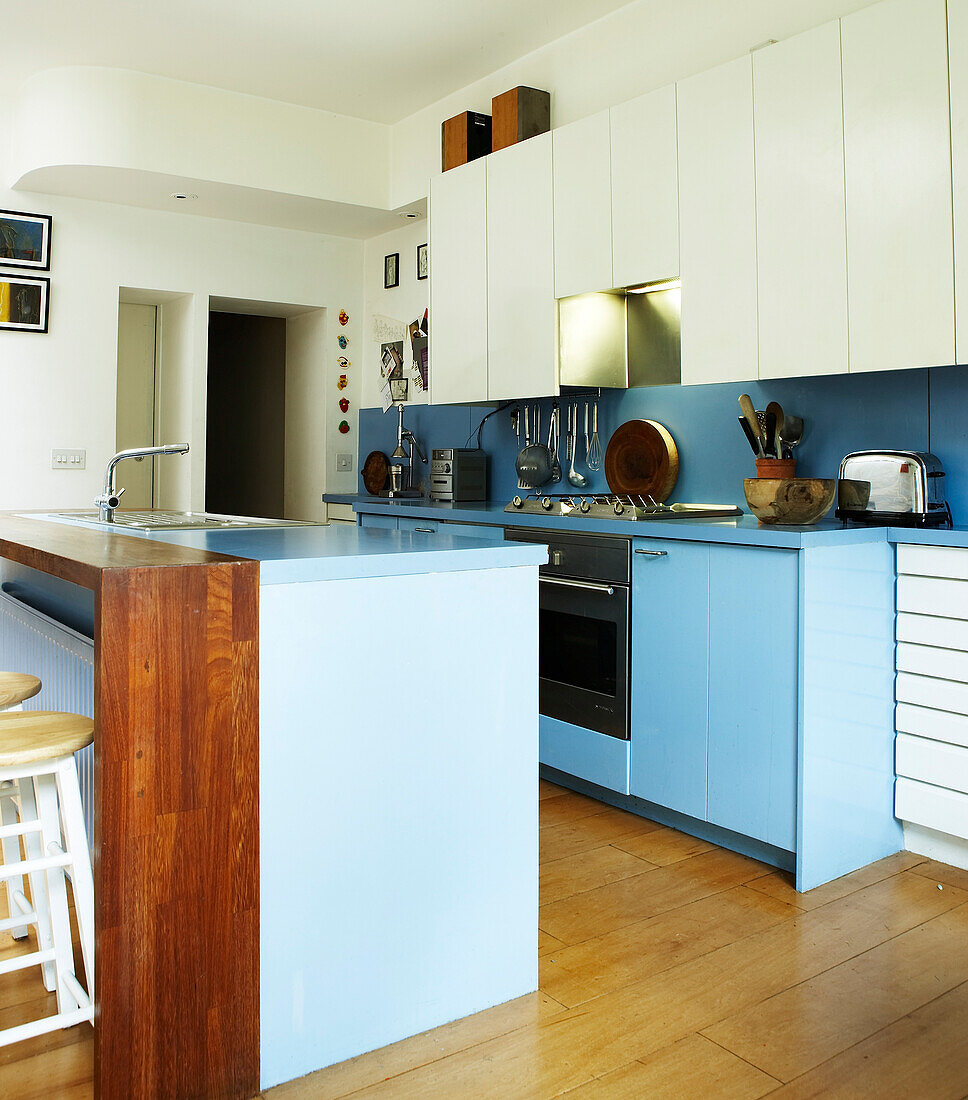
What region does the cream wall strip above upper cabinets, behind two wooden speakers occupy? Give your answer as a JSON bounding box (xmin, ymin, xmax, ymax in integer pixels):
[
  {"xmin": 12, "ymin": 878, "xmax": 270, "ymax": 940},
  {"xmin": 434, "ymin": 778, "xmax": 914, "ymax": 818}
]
[{"xmin": 391, "ymin": 0, "xmax": 872, "ymax": 208}]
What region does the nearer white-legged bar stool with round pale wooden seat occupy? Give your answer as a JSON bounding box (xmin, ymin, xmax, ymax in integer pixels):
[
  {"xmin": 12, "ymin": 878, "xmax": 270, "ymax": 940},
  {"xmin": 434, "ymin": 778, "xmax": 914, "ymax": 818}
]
[{"xmin": 0, "ymin": 711, "xmax": 95, "ymax": 1047}]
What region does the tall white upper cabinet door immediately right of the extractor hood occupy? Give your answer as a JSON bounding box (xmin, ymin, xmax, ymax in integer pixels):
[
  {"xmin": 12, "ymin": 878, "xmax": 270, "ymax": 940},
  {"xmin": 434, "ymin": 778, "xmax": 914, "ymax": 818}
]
[{"xmin": 677, "ymin": 57, "xmax": 757, "ymax": 383}]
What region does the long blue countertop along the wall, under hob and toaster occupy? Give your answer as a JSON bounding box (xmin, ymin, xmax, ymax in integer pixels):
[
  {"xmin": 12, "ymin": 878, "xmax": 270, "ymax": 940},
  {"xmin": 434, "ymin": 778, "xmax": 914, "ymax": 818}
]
[{"xmin": 322, "ymin": 493, "xmax": 968, "ymax": 550}]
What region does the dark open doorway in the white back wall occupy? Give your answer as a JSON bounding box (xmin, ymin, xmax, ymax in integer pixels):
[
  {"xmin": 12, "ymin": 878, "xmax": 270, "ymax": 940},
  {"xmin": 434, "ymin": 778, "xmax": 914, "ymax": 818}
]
[{"xmin": 205, "ymin": 310, "xmax": 286, "ymax": 519}]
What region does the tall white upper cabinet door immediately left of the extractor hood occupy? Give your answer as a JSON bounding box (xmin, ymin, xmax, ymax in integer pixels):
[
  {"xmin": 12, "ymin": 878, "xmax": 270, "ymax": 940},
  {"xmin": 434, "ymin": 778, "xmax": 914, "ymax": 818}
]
[{"xmin": 488, "ymin": 133, "xmax": 558, "ymax": 400}]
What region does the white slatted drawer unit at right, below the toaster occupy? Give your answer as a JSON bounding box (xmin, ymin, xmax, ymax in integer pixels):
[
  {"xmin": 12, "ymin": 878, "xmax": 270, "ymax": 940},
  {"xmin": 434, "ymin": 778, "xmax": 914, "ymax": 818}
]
[{"xmin": 894, "ymin": 546, "xmax": 968, "ymax": 839}]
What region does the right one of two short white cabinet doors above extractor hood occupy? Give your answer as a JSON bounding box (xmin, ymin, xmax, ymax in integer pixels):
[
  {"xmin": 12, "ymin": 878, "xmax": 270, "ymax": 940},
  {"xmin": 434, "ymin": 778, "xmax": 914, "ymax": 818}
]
[{"xmin": 609, "ymin": 85, "xmax": 679, "ymax": 286}]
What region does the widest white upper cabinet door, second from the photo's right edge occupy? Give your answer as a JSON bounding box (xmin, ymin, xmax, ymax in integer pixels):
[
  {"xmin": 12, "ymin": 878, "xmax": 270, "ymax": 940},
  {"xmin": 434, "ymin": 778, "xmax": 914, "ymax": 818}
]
[{"xmin": 842, "ymin": 0, "xmax": 955, "ymax": 371}]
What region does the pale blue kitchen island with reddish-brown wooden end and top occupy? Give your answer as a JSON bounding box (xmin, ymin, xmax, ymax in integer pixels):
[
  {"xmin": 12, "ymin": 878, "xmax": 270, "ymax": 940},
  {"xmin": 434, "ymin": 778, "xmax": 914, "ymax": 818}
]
[{"xmin": 0, "ymin": 515, "xmax": 545, "ymax": 1097}]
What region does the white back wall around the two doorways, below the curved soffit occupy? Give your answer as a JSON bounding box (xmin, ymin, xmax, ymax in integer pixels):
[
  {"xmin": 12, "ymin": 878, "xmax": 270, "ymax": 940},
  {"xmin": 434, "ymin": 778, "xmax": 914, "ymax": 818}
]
[{"xmin": 0, "ymin": 119, "xmax": 363, "ymax": 508}]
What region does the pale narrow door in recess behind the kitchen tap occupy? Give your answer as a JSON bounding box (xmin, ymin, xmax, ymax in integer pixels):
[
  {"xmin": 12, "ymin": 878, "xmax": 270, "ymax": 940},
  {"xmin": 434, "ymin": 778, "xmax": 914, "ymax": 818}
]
[{"xmin": 116, "ymin": 301, "xmax": 158, "ymax": 508}]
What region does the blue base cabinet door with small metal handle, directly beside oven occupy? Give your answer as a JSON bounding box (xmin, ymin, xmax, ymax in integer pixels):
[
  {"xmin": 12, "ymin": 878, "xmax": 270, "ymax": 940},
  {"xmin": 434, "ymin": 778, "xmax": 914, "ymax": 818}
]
[{"xmin": 629, "ymin": 539, "xmax": 717, "ymax": 821}]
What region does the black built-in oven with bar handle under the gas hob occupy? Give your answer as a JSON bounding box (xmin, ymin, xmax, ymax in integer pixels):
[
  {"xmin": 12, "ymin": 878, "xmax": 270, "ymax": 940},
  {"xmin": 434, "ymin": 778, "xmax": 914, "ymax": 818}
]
[{"xmin": 505, "ymin": 527, "xmax": 631, "ymax": 740}]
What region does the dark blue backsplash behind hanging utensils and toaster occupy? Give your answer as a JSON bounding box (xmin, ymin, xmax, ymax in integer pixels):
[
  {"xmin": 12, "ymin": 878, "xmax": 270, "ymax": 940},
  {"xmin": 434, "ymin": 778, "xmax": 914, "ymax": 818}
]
[{"xmin": 360, "ymin": 366, "xmax": 968, "ymax": 524}]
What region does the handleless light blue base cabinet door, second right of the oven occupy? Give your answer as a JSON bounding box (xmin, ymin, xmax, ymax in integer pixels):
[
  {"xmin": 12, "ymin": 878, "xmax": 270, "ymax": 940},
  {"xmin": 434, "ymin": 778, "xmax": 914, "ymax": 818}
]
[{"xmin": 706, "ymin": 546, "xmax": 799, "ymax": 851}]
